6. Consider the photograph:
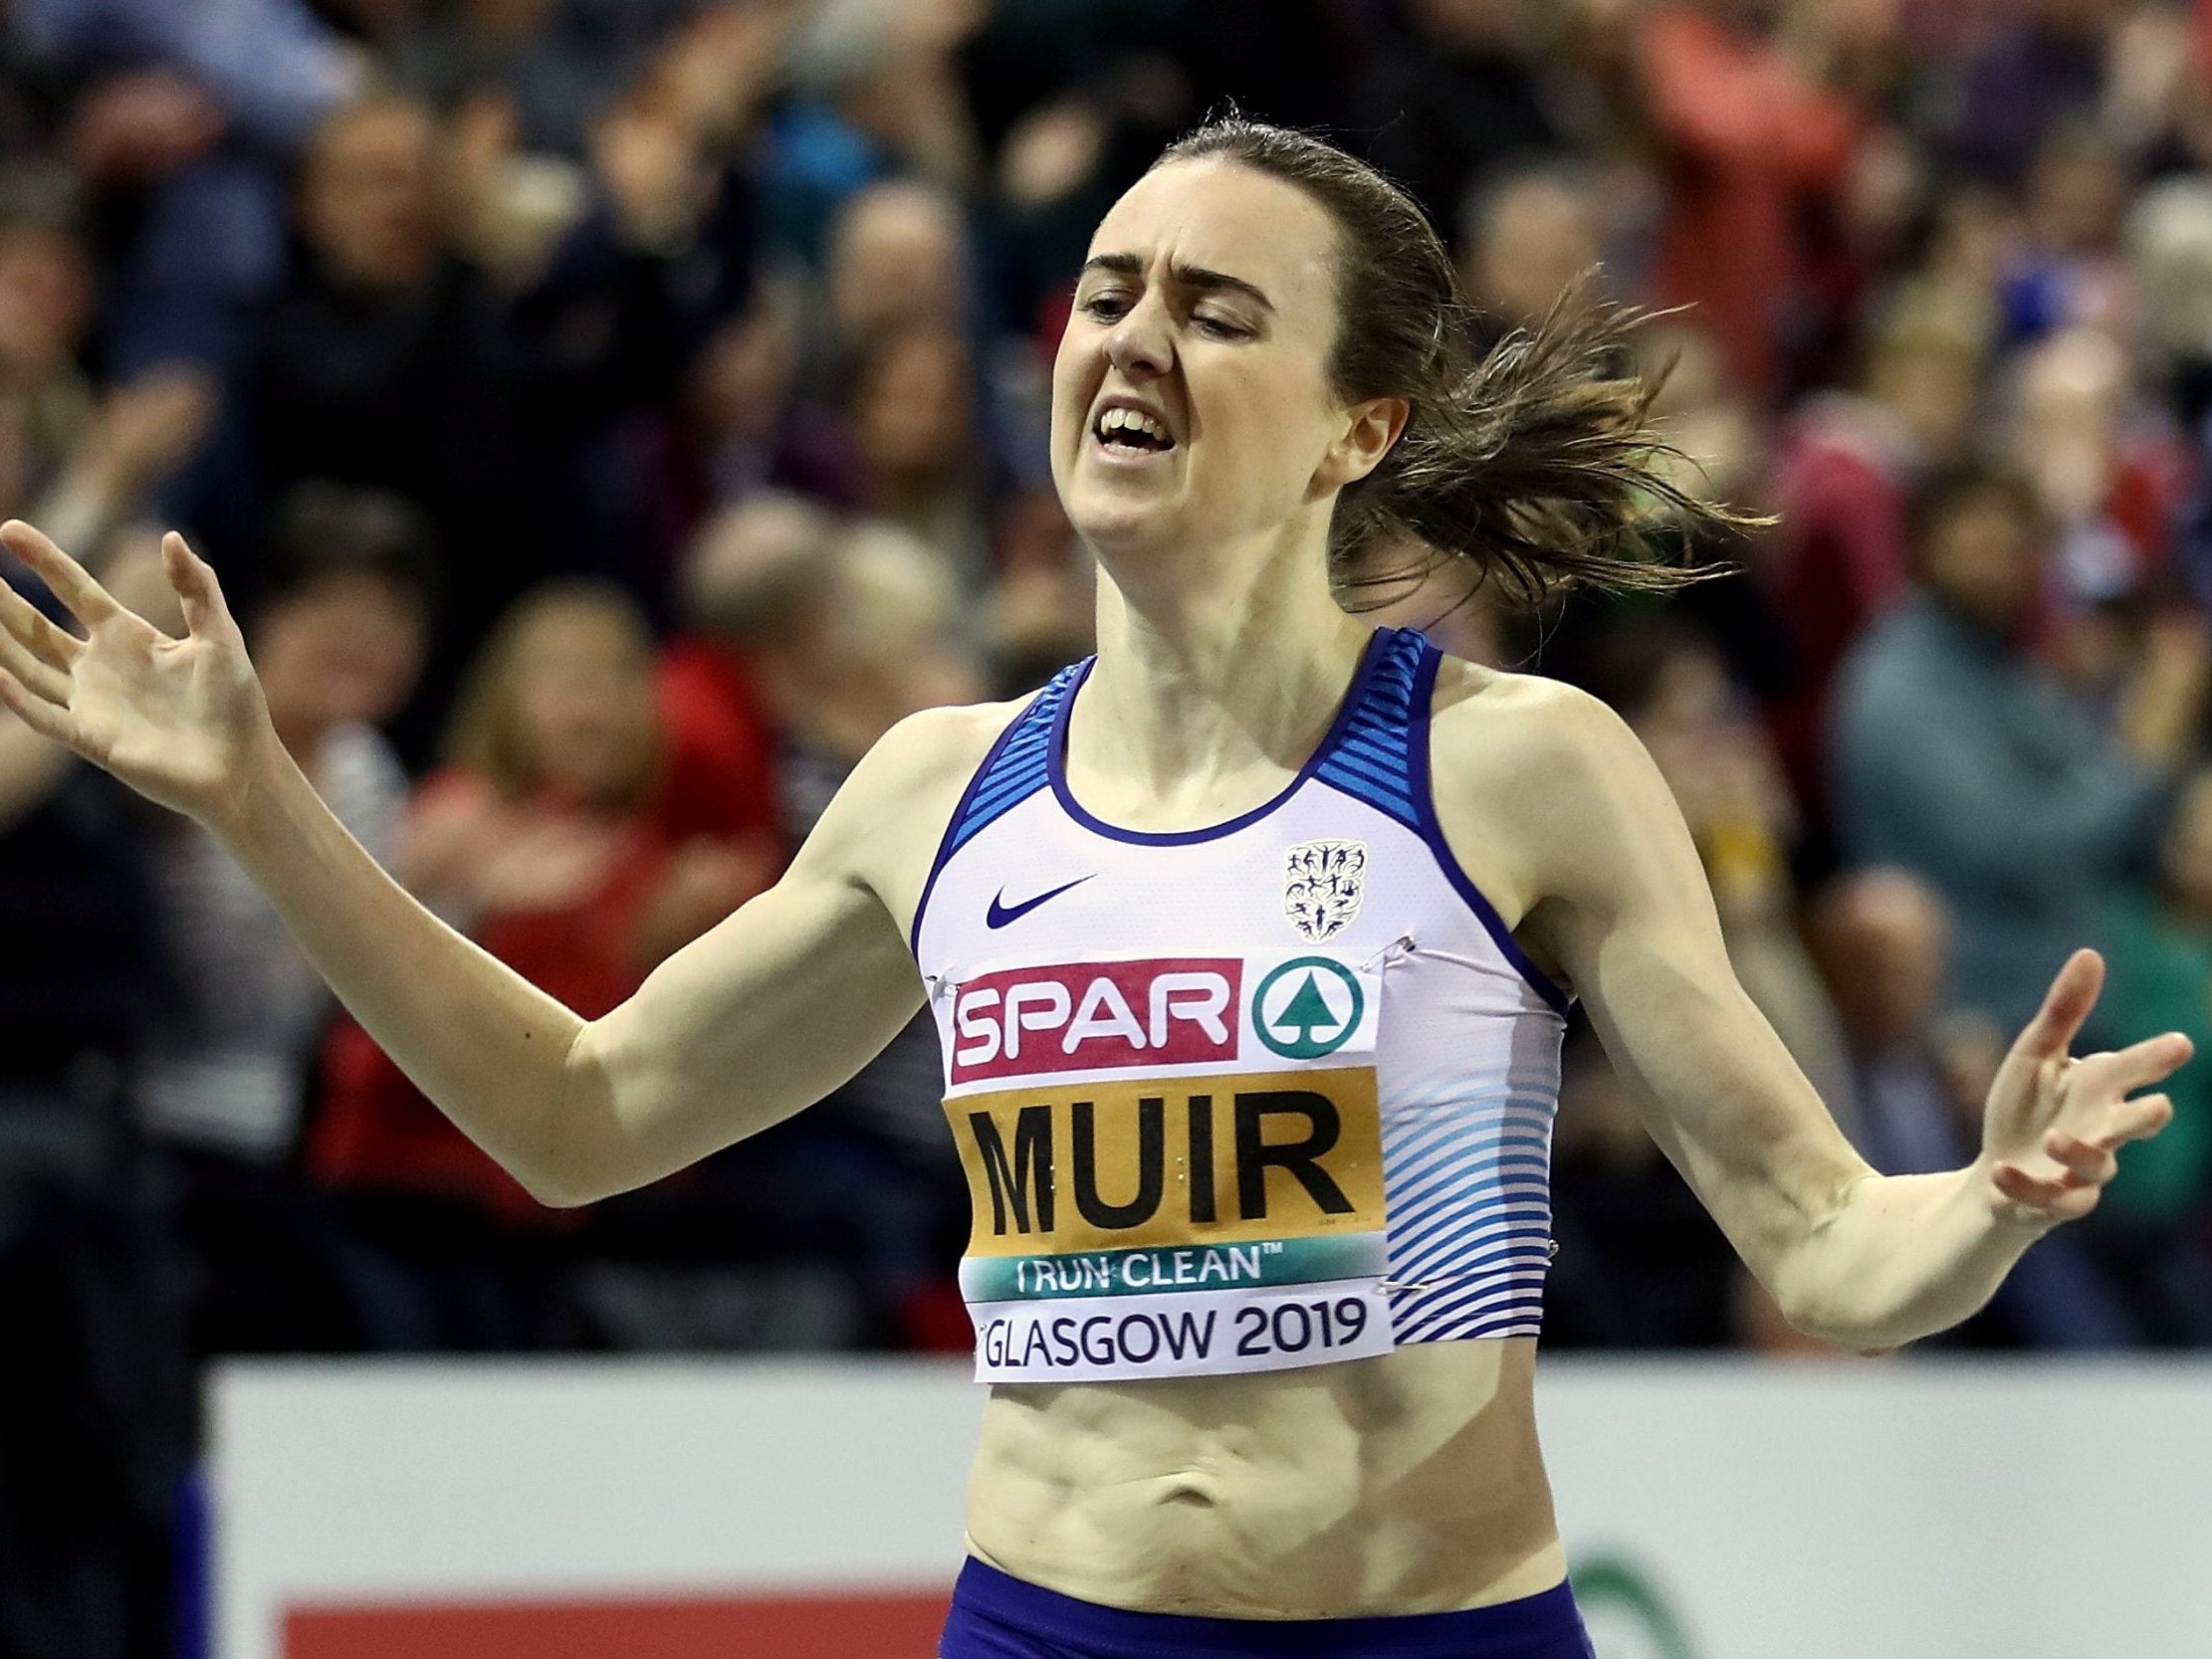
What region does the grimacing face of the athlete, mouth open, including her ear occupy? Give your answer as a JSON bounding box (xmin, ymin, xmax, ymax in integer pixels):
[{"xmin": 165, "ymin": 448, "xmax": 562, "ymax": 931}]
[{"xmin": 1053, "ymin": 159, "xmax": 1381, "ymax": 559}]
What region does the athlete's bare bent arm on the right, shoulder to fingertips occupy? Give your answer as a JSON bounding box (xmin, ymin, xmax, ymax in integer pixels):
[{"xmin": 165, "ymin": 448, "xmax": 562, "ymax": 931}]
[{"xmin": 1436, "ymin": 682, "xmax": 2190, "ymax": 1349}]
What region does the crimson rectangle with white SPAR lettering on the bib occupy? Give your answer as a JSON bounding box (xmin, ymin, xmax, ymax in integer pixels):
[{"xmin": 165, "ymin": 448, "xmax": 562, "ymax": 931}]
[{"xmin": 951, "ymin": 955, "xmax": 1247, "ymax": 1084}]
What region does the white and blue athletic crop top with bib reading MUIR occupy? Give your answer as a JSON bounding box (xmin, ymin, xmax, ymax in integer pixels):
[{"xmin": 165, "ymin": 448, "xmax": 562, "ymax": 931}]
[{"xmin": 914, "ymin": 630, "xmax": 1568, "ymax": 1382}]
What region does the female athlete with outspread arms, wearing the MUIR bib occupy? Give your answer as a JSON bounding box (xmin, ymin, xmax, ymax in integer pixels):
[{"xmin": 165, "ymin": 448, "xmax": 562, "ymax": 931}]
[{"xmin": 0, "ymin": 121, "xmax": 2188, "ymax": 1659}]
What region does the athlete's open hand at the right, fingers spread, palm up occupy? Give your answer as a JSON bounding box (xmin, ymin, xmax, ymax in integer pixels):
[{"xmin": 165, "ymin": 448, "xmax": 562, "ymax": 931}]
[{"xmin": 1980, "ymin": 951, "xmax": 2192, "ymax": 1225}]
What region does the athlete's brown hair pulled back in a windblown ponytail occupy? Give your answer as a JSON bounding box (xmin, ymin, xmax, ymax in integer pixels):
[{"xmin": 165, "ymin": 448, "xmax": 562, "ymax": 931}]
[{"xmin": 1153, "ymin": 115, "xmax": 1758, "ymax": 608}]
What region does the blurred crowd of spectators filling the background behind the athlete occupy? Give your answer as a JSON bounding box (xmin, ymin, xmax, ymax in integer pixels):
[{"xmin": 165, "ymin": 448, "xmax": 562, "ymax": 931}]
[{"xmin": 0, "ymin": 0, "xmax": 2212, "ymax": 1659}]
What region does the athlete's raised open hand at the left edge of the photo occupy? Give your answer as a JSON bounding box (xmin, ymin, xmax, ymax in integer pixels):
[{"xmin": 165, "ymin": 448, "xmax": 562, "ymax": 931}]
[{"xmin": 0, "ymin": 519, "xmax": 272, "ymax": 827}]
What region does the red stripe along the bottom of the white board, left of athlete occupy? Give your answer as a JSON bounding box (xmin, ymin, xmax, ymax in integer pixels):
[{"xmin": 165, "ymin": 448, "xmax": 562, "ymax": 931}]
[{"xmin": 283, "ymin": 1590, "xmax": 951, "ymax": 1659}]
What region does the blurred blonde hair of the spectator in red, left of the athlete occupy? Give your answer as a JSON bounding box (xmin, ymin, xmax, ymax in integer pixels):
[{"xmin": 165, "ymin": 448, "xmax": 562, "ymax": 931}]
[{"xmin": 445, "ymin": 577, "xmax": 664, "ymax": 809}]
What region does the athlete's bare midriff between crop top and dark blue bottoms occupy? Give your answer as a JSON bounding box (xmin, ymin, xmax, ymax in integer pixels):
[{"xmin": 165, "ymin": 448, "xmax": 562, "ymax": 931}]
[{"xmin": 967, "ymin": 1339, "xmax": 1566, "ymax": 1619}]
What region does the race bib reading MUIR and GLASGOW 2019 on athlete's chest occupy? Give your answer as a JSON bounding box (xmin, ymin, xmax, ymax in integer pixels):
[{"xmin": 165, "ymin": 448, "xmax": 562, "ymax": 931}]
[{"xmin": 945, "ymin": 951, "xmax": 1394, "ymax": 1382}]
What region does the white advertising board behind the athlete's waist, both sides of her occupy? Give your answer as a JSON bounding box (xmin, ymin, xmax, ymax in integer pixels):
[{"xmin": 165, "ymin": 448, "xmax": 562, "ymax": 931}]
[{"xmin": 210, "ymin": 1360, "xmax": 2212, "ymax": 1659}]
